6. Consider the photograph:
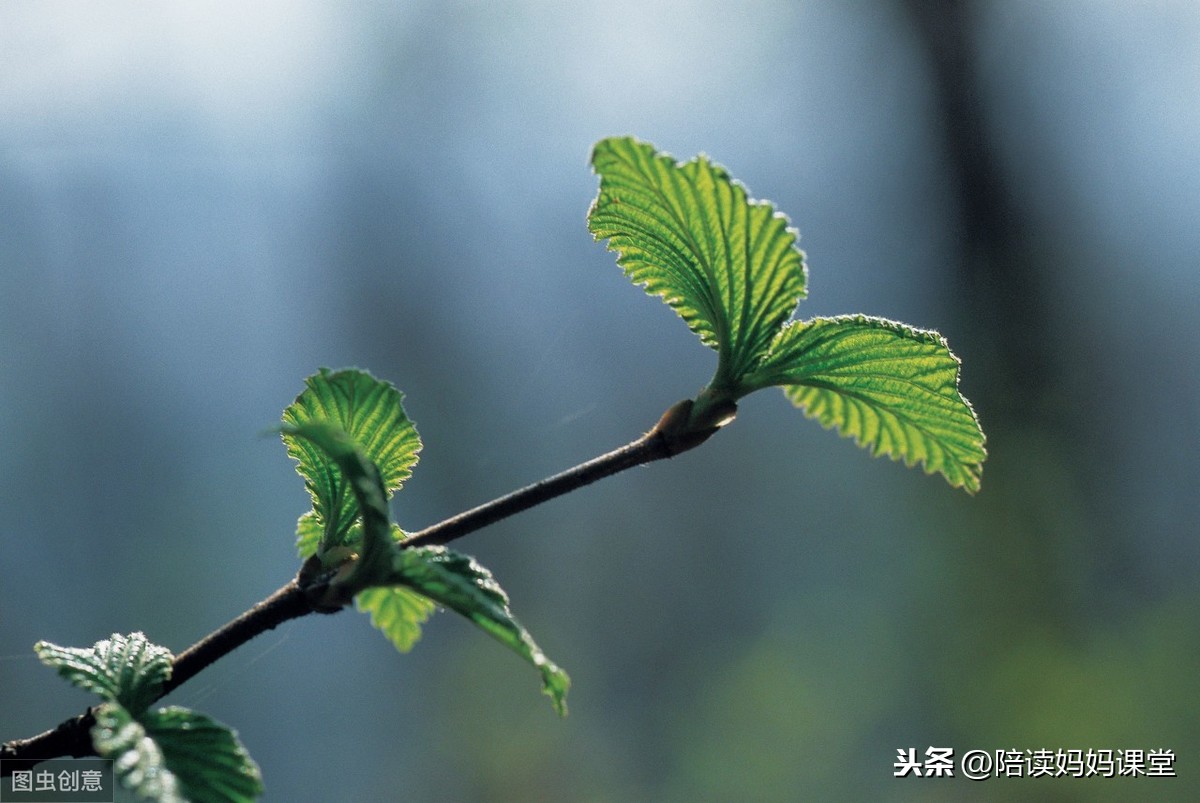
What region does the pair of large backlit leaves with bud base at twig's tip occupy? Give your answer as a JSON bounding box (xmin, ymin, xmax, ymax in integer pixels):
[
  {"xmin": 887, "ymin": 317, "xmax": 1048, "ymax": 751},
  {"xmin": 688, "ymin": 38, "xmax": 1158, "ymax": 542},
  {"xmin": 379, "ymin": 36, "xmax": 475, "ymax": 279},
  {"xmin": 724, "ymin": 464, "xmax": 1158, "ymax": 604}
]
[{"xmin": 588, "ymin": 138, "xmax": 986, "ymax": 493}]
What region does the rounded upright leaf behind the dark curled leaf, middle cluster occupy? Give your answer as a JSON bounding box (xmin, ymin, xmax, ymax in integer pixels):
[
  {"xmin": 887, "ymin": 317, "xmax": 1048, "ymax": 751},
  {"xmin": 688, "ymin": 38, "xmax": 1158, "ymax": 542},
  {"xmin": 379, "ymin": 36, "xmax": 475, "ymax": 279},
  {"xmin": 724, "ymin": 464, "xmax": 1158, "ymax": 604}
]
[{"xmin": 283, "ymin": 368, "xmax": 421, "ymax": 558}]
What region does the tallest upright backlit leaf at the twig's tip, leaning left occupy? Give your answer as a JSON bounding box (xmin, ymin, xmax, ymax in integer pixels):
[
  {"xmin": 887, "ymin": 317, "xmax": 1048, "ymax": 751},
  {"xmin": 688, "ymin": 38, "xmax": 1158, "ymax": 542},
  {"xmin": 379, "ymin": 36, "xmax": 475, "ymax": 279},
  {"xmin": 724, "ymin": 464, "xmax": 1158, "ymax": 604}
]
[{"xmin": 588, "ymin": 137, "xmax": 806, "ymax": 386}]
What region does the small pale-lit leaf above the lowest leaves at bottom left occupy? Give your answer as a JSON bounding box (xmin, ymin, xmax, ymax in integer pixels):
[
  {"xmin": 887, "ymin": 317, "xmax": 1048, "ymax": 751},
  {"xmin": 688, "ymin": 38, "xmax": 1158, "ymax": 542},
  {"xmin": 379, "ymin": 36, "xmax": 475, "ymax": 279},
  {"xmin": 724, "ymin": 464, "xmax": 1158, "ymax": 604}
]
[{"xmin": 34, "ymin": 633, "xmax": 174, "ymax": 714}]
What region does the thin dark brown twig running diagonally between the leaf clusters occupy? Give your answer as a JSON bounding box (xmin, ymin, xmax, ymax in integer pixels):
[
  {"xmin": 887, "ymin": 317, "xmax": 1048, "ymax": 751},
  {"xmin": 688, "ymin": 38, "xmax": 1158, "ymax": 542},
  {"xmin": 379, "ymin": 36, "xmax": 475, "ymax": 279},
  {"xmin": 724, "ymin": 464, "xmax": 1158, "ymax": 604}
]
[{"xmin": 0, "ymin": 400, "xmax": 736, "ymax": 775}]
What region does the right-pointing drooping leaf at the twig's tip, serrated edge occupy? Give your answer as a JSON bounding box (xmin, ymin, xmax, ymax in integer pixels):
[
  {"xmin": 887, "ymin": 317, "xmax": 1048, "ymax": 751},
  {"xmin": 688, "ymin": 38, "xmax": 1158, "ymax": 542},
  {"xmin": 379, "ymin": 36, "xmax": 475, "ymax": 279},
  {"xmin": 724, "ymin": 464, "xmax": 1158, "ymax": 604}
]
[{"xmin": 743, "ymin": 316, "xmax": 986, "ymax": 493}]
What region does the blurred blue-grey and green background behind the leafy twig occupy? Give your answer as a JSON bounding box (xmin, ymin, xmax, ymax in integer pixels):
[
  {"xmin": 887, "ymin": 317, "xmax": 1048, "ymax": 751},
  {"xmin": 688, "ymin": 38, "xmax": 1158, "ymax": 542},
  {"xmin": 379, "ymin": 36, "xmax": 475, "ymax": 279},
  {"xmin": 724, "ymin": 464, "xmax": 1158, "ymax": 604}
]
[{"xmin": 0, "ymin": 0, "xmax": 1200, "ymax": 801}]
